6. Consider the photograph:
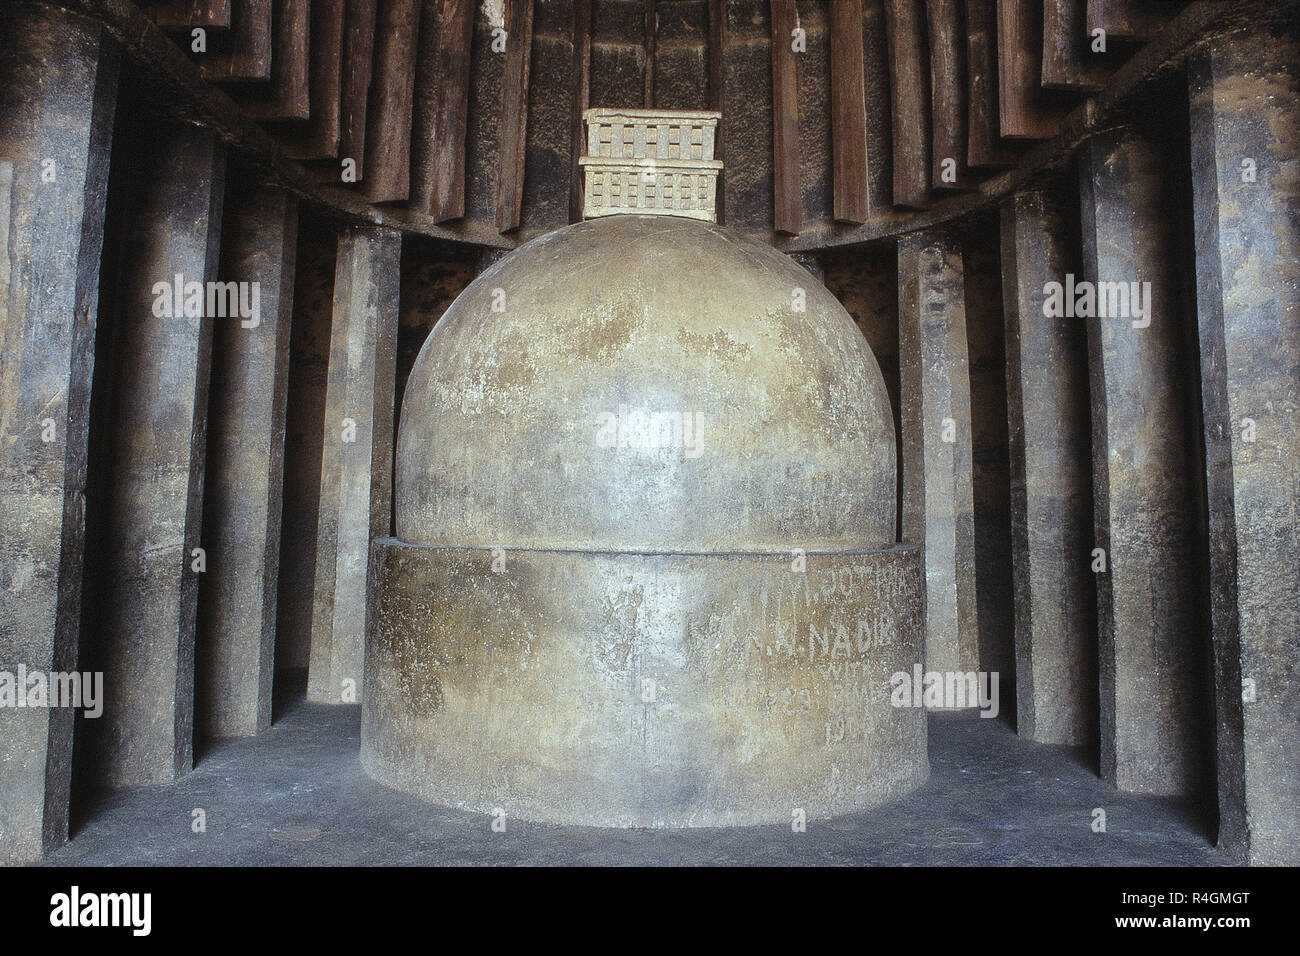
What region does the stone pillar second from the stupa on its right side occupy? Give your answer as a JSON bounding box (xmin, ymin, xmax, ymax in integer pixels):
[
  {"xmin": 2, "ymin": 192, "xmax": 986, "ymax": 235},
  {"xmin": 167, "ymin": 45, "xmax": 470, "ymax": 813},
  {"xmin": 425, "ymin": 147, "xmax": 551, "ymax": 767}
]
[{"xmin": 1002, "ymin": 193, "xmax": 1097, "ymax": 745}]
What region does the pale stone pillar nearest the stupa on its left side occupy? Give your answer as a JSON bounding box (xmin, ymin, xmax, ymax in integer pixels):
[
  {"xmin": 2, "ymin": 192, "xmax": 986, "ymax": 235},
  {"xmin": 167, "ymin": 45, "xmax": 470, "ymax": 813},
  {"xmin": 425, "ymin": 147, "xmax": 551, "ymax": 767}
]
[{"xmin": 307, "ymin": 229, "xmax": 402, "ymax": 704}]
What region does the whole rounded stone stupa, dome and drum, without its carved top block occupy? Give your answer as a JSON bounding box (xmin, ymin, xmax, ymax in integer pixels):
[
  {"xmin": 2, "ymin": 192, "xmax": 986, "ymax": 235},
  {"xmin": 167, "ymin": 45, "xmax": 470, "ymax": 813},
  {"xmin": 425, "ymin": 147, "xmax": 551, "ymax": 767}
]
[{"xmin": 361, "ymin": 215, "xmax": 928, "ymax": 826}]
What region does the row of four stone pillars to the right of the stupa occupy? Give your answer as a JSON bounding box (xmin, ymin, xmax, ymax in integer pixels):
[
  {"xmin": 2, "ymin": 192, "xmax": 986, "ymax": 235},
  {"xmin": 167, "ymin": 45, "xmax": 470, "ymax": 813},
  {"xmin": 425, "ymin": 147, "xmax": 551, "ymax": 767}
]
[{"xmin": 898, "ymin": 22, "xmax": 1300, "ymax": 864}]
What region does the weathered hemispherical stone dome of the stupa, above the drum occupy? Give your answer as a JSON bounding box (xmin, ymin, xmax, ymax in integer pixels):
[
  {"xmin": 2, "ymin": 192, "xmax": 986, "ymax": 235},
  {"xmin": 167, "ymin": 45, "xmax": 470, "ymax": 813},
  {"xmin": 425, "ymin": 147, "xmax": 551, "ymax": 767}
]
[{"xmin": 395, "ymin": 215, "xmax": 896, "ymax": 553}]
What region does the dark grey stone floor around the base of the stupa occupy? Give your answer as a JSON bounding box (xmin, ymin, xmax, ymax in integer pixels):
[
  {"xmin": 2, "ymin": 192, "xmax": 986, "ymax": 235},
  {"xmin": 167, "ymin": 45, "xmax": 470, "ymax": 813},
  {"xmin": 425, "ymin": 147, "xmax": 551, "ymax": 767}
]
[{"xmin": 46, "ymin": 701, "xmax": 1230, "ymax": 866}]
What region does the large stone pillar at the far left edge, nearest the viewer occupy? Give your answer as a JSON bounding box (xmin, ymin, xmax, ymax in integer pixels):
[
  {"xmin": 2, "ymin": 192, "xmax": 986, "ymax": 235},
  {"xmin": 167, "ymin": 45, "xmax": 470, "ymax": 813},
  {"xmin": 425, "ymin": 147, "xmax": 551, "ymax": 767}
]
[{"xmin": 0, "ymin": 4, "xmax": 118, "ymax": 864}]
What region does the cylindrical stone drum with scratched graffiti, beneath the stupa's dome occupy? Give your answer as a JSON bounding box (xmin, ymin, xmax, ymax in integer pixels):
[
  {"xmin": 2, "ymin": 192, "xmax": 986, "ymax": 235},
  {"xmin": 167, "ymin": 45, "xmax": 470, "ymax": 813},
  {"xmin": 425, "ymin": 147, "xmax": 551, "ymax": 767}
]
[{"xmin": 361, "ymin": 538, "xmax": 928, "ymax": 826}]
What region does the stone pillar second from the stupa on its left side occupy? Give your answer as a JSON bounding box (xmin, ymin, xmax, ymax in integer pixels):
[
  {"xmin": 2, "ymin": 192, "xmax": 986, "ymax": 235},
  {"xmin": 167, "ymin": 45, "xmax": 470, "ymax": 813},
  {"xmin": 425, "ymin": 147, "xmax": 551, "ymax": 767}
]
[{"xmin": 195, "ymin": 190, "xmax": 298, "ymax": 736}]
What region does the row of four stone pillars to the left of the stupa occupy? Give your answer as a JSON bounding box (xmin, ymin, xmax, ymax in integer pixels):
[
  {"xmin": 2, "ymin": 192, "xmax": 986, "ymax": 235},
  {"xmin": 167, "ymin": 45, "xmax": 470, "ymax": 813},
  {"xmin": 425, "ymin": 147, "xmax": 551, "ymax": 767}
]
[{"xmin": 0, "ymin": 4, "xmax": 402, "ymax": 862}]
